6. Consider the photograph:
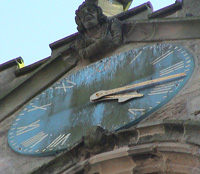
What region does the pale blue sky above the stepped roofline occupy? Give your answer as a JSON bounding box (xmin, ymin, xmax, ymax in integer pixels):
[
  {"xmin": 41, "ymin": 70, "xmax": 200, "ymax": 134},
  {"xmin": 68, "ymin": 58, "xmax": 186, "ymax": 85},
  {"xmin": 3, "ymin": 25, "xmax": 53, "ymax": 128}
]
[{"xmin": 0, "ymin": 0, "xmax": 175, "ymax": 66}]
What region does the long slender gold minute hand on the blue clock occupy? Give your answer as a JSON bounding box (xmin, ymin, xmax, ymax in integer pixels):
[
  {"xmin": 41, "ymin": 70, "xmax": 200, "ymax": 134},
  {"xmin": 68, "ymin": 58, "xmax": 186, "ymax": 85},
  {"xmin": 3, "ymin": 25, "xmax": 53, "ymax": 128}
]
[{"xmin": 90, "ymin": 73, "xmax": 186, "ymax": 101}]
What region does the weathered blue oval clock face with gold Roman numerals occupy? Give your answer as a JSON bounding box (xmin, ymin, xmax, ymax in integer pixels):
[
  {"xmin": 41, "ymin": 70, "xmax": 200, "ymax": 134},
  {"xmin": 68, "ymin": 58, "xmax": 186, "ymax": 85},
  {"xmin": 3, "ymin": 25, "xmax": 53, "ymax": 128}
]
[{"xmin": 8, "ymin": 44, "xmax": 194, "ymax": 156}]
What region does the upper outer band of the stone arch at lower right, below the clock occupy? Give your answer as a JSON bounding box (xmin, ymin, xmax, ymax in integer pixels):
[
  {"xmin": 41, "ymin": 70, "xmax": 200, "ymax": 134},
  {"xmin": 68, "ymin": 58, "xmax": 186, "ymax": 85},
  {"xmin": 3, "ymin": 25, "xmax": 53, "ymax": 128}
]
[{"xmin": 126, "ymin": 120, "xmax": 200, "ymax": 146}]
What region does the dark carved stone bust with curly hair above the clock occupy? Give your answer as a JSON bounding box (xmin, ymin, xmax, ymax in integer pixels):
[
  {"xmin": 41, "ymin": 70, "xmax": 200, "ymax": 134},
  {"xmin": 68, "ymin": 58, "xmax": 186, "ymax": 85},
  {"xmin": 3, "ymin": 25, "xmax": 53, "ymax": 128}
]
[{"xmin": 75, "ymin": 0, "xmax": 122, "ymax": 62}]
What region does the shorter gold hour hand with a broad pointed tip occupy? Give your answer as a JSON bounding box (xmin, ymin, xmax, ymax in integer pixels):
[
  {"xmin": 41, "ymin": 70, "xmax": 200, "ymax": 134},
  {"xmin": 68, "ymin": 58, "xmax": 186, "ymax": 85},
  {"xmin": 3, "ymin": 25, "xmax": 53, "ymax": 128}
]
[{"xmin": 90, "ymin": 91, "xmax": 144, "ymax": 103}]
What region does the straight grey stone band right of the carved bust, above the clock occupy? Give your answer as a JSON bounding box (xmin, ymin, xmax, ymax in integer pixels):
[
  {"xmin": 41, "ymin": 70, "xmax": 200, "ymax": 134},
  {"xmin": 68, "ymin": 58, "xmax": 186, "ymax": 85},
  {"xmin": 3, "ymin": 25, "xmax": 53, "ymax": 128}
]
[{"xmin": 123, "ymin": 17, "xmax": 200, "ymax": 43}]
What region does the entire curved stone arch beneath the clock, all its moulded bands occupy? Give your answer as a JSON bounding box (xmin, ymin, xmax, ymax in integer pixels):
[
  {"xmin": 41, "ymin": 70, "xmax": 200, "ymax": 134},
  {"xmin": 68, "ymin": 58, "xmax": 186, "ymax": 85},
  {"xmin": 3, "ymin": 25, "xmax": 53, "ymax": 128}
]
[{"xmin": 30, "ymin": 120, "xmax": 200, "ymax": 174}]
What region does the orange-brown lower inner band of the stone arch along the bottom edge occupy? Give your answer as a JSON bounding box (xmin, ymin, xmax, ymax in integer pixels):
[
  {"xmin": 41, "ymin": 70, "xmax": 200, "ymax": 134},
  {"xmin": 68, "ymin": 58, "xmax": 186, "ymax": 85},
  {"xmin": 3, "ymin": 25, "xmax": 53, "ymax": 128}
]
[{"xmin": 62, "ymin": 143, "xmax": 200, "ymax": 174}]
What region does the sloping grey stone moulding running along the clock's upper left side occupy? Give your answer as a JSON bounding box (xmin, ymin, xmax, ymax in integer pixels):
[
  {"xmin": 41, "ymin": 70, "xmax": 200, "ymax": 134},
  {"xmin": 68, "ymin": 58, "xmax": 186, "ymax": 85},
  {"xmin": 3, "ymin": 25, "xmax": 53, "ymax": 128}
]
[{"xmin": 0, "ymin": 56, "xmax": 77, "ymax": 121}]
